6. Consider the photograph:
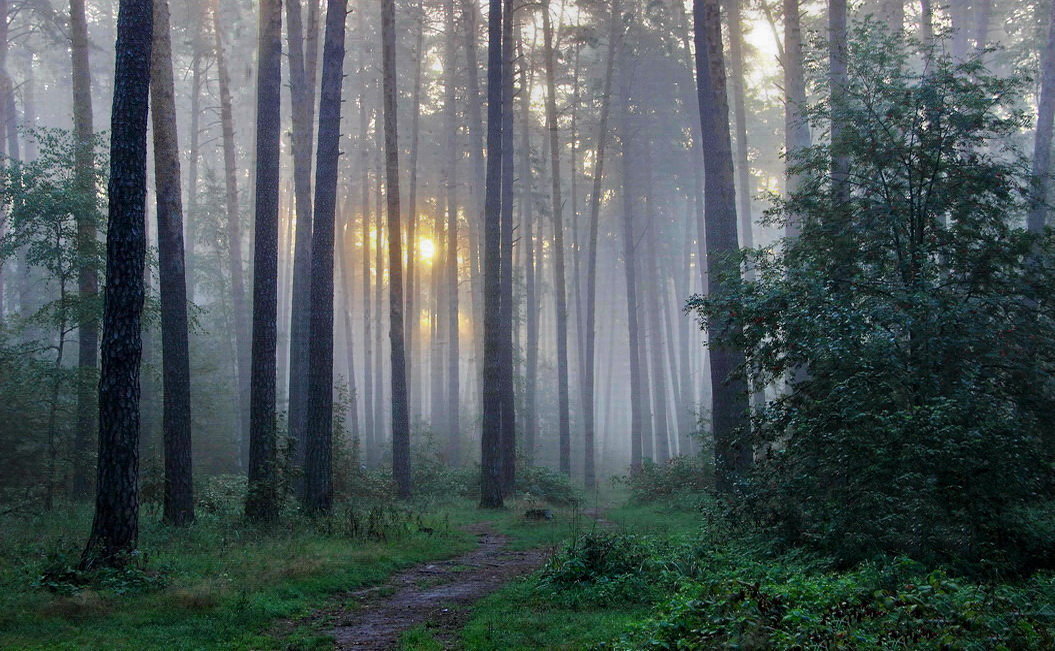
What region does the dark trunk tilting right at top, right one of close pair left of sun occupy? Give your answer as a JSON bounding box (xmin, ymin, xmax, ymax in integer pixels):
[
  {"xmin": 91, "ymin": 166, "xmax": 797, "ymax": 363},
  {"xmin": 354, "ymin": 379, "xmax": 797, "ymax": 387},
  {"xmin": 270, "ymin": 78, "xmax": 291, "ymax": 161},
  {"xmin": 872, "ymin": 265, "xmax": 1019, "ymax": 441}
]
[{"xmin": 304, "ymin": 0, "xmax": 348, "ymax": 513}]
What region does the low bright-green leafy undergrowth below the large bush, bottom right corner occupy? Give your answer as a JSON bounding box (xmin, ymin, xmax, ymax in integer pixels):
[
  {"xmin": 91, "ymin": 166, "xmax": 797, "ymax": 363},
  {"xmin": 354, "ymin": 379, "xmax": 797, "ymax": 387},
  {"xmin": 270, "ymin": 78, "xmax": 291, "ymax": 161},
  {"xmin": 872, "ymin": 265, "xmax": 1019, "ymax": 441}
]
[{"xmin": 614, "ymin": 550, "xmax": 1055, "ymax": 649}]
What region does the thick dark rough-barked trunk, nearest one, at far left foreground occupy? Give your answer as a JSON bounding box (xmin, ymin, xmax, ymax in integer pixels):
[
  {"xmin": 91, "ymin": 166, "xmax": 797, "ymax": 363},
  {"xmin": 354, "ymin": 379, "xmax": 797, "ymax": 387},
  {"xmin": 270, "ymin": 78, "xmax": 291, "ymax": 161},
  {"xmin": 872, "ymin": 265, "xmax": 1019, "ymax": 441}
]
[{"xmin": 80, "ymin": 0, "xmax": 153, "ymax": 569}]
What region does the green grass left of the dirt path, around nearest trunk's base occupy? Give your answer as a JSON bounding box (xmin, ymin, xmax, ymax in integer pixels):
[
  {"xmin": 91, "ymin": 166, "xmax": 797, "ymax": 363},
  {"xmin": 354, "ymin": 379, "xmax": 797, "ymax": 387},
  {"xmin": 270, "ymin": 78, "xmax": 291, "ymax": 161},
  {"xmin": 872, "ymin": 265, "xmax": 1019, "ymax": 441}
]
[{"xmin": 0, "ymin": 498, "xmax": 474, "ymax": 649}]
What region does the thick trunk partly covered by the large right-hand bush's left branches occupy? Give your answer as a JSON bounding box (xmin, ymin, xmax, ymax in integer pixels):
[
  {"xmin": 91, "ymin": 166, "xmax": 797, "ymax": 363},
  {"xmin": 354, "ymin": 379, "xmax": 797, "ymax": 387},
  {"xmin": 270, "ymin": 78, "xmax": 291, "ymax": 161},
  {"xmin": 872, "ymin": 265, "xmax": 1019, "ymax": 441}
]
[{"xmin": 693, "ymin": 0, "xmax": 751, "ymax": 493}]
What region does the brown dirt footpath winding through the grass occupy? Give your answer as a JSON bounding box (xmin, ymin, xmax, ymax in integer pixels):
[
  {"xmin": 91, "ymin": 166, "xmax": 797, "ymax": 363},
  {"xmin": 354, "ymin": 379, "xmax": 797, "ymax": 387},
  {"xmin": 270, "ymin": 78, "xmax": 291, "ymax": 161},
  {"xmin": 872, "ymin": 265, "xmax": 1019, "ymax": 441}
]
[{"xmin": 327, "ymin": 528, "xmax": 550, "ymax": 649}]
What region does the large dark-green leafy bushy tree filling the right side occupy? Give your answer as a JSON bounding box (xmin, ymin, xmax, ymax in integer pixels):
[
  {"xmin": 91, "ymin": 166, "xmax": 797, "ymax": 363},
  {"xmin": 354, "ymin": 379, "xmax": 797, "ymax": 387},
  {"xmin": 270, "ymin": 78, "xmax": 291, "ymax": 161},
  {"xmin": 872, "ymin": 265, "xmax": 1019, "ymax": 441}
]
[{"xmin": 689, "ymin": 25, "xmax": 1055, "ymax": 569}]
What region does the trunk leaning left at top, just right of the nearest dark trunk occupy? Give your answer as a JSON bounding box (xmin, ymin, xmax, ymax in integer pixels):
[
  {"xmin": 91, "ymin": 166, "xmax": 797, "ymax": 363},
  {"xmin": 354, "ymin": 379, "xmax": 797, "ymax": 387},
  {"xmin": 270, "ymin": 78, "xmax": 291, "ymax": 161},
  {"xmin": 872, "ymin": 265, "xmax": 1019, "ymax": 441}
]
[{"xmin": 150, "ymin": 0, "xmax": 194, "ymax": 526}]
